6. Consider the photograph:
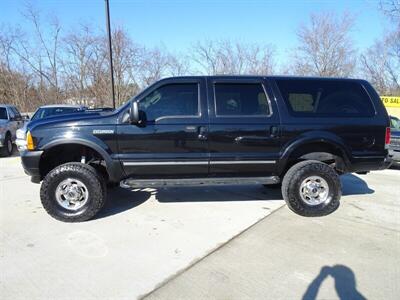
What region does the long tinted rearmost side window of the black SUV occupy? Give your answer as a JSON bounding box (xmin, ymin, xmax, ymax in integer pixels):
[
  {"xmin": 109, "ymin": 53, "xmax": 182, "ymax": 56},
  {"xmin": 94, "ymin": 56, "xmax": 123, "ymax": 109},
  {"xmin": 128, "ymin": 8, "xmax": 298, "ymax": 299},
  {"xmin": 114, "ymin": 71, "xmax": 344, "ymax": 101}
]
[{"xmin": 276, "ymin": 79, "xmax": 375, "ymax": 117}]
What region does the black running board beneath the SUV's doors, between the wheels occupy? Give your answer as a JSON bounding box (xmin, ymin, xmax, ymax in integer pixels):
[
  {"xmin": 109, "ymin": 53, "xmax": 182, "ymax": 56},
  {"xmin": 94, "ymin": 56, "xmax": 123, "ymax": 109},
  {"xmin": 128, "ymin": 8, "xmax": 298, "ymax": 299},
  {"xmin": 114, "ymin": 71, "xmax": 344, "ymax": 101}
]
[{"xmin": 120, "ymin": 176, "xmax": 280, "ymax": 188}]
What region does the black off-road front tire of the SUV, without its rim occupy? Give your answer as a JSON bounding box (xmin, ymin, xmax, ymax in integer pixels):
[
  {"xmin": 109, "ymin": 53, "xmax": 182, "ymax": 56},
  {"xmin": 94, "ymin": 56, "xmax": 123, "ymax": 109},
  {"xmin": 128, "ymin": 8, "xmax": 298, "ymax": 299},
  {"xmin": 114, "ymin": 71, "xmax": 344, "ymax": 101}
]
[{"xmin": 40, "ymin": 162, "xmax": 107, "ymax": 222}]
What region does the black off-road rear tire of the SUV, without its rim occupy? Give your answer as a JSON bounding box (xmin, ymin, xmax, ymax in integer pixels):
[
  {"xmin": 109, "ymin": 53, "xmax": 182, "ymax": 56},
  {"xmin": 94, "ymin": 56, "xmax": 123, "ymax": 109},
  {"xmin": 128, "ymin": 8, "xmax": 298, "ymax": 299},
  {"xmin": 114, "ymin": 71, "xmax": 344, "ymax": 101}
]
[{"xmin": 282, "ymin": 160, "xmax": 342, "ymax": 217}]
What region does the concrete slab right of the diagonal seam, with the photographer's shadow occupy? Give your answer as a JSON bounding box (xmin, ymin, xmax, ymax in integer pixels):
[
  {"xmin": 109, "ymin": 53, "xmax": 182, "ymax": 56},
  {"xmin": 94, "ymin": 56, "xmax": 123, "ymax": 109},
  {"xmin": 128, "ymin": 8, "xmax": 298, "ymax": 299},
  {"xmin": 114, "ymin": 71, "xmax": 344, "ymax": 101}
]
[{"xmin": 145, "ymin": 170, "xmax": 400, "ymax": 300}]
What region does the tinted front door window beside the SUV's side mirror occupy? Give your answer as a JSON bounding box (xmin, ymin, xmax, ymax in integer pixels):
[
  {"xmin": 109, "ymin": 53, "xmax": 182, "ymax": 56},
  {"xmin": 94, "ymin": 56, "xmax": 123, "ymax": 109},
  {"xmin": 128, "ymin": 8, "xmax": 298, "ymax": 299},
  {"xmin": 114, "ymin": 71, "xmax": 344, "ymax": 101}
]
[{"xmin": 140, "ymin": 83, "xmax": 199, "ymax": 121}]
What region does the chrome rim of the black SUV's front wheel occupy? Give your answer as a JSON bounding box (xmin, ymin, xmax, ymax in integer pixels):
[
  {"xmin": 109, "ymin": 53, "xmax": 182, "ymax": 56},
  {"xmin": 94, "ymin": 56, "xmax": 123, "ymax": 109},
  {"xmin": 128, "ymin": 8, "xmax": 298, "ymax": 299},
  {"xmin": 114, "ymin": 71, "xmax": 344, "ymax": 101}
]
[{"xmin": 56, "ymin": 178, "xmax": 89, "ymax": 211}]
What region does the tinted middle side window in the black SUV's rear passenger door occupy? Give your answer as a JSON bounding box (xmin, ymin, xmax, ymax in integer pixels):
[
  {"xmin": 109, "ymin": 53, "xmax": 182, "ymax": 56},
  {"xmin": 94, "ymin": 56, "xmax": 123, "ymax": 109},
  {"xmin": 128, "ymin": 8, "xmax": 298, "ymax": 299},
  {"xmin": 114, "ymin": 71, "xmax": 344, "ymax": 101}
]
[{"xmin": 214, "ymin": 83, "xmax": 270, "ymax": 116}]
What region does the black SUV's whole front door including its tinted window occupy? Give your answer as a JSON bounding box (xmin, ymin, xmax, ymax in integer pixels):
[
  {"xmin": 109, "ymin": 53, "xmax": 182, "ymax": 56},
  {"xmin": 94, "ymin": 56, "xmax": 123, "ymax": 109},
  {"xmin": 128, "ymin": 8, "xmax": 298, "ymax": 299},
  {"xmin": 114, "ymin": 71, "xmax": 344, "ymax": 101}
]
[{"xmin": 117, "ymin": 78, "xmax": 209, "ymax": 178}]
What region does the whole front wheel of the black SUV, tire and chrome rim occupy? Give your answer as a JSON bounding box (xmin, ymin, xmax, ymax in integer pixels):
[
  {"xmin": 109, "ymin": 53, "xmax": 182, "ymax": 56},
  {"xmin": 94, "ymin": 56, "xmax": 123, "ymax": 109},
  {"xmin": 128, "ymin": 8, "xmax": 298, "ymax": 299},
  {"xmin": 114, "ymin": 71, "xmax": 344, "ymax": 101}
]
[{"xmin": 40, "ymin": 162, "xmax": 106, "ymax": 222}]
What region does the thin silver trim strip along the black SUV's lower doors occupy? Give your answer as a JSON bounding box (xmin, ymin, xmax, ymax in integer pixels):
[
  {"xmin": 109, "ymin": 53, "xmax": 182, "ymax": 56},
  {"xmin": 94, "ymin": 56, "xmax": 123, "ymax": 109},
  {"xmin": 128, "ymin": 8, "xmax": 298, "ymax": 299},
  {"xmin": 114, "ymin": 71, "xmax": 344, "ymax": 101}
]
[{"xmin": 123, "ymin": 160, "xmax": 276, "ymax": 166}]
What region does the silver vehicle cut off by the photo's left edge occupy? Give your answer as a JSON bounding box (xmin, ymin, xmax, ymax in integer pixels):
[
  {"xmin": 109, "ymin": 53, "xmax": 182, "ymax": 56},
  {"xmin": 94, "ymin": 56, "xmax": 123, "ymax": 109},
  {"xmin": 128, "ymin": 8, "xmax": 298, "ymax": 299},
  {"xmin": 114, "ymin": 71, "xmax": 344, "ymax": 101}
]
[{"xmin": 0, "ymin": 104, "xmax": 24, "ymax": 156}]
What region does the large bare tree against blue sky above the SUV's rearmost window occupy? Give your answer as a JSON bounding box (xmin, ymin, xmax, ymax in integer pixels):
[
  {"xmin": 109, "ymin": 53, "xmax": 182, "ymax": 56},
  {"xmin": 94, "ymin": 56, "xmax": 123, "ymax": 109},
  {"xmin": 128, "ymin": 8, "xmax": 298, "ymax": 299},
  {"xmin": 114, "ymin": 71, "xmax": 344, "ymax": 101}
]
[{"xmin": 292, "ymin": 13, "xmax": 357, "ymax": 77}]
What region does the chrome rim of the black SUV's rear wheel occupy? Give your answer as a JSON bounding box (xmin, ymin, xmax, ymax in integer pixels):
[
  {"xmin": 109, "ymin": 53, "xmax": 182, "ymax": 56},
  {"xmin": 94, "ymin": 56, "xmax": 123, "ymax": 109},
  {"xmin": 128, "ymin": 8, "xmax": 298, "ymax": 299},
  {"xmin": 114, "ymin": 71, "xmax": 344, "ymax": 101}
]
[{"xmin": 300, "ymin": 176, "xmax": 330, "ymax": 206}]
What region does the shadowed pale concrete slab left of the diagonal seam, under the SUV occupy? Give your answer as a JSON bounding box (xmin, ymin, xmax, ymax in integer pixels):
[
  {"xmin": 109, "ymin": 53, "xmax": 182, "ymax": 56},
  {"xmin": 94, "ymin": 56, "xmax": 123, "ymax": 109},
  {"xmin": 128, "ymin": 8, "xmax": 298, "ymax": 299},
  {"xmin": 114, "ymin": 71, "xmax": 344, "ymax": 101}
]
[{"xmin": 0, "ymin": 157, "xmax": 284, "ymax": 299}]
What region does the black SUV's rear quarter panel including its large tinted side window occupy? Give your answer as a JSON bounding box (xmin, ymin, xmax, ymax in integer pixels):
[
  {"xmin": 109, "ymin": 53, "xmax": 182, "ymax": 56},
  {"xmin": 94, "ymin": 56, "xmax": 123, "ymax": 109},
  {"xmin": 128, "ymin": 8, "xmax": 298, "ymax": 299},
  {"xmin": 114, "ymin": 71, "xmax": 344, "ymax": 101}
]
[{"xmin": 275, "ymin": 78, "xmax": 388, "ymax": 160}]
